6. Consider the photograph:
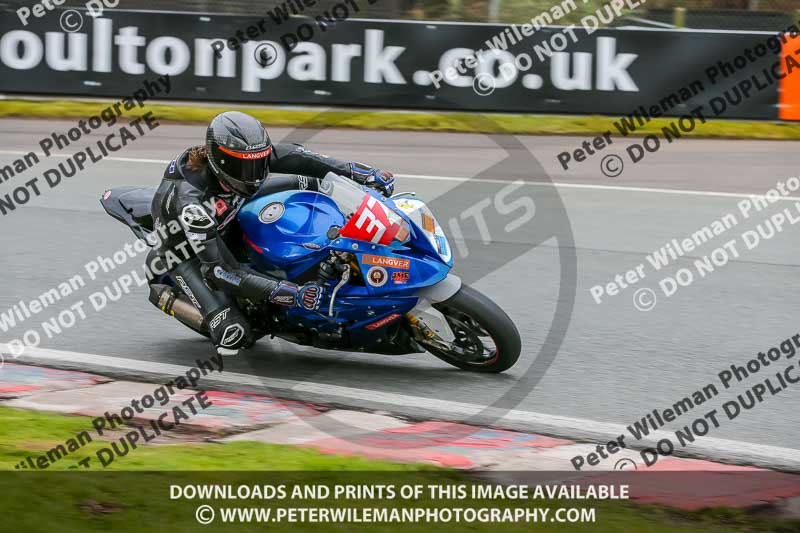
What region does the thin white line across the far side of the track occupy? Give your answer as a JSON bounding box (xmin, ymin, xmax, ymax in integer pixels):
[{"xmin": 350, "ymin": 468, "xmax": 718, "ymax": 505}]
[{"xmin": 0, "ymin": 150, "xmax": 800, "ymax": 201}]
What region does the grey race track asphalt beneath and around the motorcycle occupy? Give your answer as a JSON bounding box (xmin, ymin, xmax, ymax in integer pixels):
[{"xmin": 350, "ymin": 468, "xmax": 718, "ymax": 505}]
[{"xmin": 0, "ymin": 120, "xmax": 800, "ymax": 462}]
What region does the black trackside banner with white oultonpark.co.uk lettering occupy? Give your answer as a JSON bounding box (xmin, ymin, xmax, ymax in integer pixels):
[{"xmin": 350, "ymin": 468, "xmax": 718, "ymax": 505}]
[{"xmin": 0, "ymin": 8, "xmax": 780, "ymax": 119}]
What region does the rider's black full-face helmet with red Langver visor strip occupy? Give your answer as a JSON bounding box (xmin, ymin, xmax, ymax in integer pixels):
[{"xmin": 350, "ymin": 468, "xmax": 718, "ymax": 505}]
[{"xmin": 206, "ymin": 111, "xmax": 272, "ymax": 196}]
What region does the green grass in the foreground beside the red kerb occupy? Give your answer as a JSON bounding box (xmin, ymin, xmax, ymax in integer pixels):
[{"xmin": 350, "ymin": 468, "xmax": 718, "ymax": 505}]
[{"xmin": 0, "ymin": 407, "xmax": 800, "ymax": 533}]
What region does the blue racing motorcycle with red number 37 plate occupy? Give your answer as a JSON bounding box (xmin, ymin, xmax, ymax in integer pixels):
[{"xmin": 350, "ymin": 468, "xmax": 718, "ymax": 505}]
[{"xmin": 101, "ymin": 173, "xmax": 521, "ymax": 372}]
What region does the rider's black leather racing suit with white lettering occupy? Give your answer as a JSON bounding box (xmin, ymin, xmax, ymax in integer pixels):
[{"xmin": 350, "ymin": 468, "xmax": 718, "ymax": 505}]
[{"xmin": 152, "ymin": 144, "xmax": 359, "ymax": 349}]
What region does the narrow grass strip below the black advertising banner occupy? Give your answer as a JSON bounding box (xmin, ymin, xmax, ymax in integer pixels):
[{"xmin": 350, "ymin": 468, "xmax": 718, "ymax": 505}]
[{"xmin": 0, "ymin": 100, "xmax": 800, "ymax": 140}]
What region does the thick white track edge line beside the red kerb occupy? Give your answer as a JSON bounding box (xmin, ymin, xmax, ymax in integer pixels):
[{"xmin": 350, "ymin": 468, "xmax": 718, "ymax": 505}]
[{"xmin": 0, "ymin": 344, "xmax": 800, "ymax": 471}]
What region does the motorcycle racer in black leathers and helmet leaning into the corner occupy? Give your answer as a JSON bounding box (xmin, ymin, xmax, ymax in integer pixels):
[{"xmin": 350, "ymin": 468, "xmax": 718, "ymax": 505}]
[{"xmin": 152, "ymin": 111, "xmax": 394, "ymax": 355}]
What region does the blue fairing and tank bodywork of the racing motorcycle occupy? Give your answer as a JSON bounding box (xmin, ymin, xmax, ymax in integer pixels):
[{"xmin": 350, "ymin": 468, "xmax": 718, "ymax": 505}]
[{"xmin": 239, "ymin": 185, "xmax": 452, "ymax": 351}]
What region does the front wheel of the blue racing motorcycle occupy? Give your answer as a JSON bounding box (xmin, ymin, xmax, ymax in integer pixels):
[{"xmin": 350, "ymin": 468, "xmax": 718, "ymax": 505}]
[{"xmin": 425, "ymin": 285, "xmax": 522, "ymax": 373}]
